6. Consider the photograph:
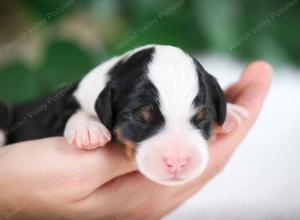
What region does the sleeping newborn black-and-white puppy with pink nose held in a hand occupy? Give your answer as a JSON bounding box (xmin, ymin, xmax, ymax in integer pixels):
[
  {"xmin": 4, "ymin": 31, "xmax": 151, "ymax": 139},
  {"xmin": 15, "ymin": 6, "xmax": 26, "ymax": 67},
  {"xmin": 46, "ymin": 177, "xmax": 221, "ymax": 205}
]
[{"xmin": 0, "ymin": 45, "xmax": 246, "ymax": 185}]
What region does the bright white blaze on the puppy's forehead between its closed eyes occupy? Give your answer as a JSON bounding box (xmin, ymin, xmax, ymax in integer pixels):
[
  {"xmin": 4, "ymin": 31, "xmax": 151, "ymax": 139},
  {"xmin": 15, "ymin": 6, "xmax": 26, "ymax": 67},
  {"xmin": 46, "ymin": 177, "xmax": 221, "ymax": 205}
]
[{"xmin": 148, "ymin": 46, "xmax": 199, "ymax": 124}]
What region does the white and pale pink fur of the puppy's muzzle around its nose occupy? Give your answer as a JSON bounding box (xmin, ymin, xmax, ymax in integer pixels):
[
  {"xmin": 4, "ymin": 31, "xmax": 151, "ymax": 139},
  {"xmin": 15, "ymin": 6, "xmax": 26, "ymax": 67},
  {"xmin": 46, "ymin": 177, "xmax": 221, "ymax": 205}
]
[{"xmin": 136, "ymin": 125, "xmax": 208, "ymax": 185}]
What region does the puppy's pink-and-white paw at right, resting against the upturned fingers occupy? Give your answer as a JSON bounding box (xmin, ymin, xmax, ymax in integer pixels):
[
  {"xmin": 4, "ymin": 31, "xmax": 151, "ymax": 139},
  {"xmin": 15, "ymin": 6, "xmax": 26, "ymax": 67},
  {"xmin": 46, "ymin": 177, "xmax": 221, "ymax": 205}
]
[{"xmin": 221, "ymin": 103, "xmax": 249, "ymax": 133}]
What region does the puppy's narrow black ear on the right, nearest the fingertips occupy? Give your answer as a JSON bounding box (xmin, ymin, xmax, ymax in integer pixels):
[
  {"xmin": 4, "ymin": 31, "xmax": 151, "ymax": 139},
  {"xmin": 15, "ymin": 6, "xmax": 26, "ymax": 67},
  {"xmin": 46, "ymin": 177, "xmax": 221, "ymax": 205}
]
[{"xmin": 206, "ymin": 73, "xmax": 226, "ymax": 125}]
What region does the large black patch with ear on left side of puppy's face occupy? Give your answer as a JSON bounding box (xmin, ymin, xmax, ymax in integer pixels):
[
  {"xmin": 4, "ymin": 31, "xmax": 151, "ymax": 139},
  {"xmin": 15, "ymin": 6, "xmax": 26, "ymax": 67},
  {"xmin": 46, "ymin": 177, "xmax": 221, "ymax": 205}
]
[{"xmin": 96, "ymin": 48, "xmax": 164, "ymax": 143}]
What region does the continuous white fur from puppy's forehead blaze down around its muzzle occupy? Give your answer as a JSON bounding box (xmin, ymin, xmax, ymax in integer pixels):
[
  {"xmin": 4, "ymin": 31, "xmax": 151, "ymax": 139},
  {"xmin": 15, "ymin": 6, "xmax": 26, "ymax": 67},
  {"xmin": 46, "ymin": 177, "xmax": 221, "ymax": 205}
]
[{"xmin": 136, "ymin": 45, "xmax": 208, "ymax": 185}]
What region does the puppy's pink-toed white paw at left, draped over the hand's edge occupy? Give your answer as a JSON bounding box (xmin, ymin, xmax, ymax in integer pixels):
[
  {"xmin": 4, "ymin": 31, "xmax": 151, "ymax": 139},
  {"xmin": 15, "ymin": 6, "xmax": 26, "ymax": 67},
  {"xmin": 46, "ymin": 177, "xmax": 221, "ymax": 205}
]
[{"xmin": 66, "ymin": 121, "xmax": 111, "ymax": 150}]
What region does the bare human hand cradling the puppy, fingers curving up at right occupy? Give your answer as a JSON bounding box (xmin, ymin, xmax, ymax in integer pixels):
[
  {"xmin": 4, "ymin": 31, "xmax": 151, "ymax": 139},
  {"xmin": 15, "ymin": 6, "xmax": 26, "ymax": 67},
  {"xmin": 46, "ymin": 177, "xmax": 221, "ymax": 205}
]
[{"xmin": 0, "ymin": 62, "xmax": 271, "ymax": 219}]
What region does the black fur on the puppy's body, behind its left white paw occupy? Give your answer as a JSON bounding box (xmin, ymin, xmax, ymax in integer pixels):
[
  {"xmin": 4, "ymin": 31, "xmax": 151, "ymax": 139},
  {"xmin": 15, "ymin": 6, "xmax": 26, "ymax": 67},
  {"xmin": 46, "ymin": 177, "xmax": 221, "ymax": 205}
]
[{"xmin": 1, "ymin": 85, "xmax": 79, "ymax": 144}]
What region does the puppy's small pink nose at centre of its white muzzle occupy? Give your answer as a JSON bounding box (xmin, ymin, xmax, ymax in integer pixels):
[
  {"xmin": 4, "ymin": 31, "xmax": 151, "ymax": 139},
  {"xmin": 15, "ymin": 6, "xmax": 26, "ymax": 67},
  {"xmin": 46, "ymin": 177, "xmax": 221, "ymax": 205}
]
[{"xmin": 164, "ymin": 156, "xmax": 189, "ymax": 174}]
